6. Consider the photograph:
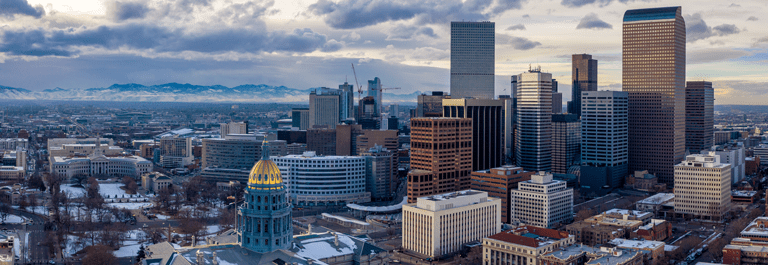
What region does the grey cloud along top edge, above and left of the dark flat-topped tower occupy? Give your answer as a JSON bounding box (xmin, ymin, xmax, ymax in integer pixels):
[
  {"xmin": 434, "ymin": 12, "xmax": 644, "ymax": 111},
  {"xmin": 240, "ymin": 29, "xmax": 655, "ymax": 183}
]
[{"xmin": 309, "ymin": 0, "xmax": 527, "ymax": 29}]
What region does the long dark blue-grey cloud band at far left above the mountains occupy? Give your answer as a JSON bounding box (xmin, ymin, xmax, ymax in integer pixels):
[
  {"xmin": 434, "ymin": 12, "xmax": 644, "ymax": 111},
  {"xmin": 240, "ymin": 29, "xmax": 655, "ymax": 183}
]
[{"xmin": 0, "ymin": 24, "xmax": 343, "ymax": 56}]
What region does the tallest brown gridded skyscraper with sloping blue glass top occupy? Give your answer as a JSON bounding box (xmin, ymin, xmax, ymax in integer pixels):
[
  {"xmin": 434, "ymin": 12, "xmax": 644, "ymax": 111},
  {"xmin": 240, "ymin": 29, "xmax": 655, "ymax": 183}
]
[{"xmin": 622, "ymin": 6, "xmax": 686, "ymax": 186}]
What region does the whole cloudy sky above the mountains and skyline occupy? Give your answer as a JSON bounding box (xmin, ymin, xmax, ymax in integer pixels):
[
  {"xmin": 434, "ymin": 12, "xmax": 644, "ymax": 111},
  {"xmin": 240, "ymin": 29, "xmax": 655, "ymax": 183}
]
[{"xmin": 0, "ymin": 0, "xmax": 768, "ymax": 104}]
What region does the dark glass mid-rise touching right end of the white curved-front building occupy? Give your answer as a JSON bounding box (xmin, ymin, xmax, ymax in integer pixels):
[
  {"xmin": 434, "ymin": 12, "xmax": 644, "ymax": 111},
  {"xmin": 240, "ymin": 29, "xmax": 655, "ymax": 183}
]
[{"xmin": 359, "ymin": 145, "xmax": 397, "ymax": 201}]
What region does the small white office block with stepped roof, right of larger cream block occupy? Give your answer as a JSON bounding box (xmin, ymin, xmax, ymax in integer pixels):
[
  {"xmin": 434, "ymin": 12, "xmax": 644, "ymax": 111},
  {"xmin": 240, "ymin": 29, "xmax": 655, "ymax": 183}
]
[{"xmin": 510, "ymin": 172, "xmax": 573, "ymax": 228}]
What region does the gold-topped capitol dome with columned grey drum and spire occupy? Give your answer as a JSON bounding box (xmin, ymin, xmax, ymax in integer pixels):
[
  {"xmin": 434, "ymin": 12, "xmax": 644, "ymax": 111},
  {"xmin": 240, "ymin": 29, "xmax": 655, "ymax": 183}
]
[{"xmin": 237, "ymin": 140, "xmax": 293, "ymax": 253}]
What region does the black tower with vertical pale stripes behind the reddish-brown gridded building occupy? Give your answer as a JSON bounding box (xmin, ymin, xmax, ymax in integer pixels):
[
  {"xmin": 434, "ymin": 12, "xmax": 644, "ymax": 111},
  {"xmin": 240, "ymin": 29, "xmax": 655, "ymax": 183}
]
[{"xmin": 443, "ymin": 99, "xmax": 505, "ymax": 171}]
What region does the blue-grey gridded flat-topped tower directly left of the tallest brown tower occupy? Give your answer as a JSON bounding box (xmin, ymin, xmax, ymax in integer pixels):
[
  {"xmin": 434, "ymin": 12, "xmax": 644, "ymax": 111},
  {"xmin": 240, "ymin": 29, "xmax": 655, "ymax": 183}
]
[{"xmin": 581, "ymin": 91, "xmax": 629, "ymax": 195}]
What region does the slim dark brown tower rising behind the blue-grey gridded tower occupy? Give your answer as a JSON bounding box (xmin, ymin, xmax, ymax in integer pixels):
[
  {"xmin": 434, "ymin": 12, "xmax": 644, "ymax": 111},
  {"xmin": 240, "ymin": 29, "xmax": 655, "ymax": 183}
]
[{"xmin": 568, "ymin": 54, "xmax": 597, "ymax": 116}]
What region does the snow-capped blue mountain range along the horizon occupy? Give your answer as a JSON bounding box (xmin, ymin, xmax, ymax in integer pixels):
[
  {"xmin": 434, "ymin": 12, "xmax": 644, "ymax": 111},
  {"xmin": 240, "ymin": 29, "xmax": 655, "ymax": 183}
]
[{"xmin": 0, "ymin": 83, "xmax": 422, "ymax": 103}]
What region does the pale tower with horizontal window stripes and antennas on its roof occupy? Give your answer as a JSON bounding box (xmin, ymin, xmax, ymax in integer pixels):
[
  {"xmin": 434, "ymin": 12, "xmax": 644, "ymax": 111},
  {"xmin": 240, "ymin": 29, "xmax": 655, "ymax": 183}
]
[{"xmin": 515, "ymin": 69, "xmax": 552, "ymax": 171}]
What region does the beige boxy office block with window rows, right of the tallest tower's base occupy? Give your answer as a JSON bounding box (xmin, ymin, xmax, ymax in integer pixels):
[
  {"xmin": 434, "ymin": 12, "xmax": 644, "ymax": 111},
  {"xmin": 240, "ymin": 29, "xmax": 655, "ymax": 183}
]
[{"xmin": 675, "ymin": 153, "xmax": 731, "ymax": 221}]
